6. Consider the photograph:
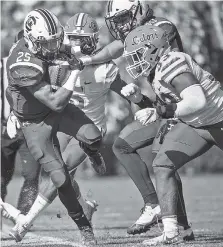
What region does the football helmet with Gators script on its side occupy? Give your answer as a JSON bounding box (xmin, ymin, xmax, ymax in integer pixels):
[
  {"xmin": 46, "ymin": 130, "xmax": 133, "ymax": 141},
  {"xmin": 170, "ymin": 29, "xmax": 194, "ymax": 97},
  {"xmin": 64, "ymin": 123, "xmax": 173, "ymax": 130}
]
[{"xmin": 123, "ymin": 25, "xmax": 170, "ymax": 79}]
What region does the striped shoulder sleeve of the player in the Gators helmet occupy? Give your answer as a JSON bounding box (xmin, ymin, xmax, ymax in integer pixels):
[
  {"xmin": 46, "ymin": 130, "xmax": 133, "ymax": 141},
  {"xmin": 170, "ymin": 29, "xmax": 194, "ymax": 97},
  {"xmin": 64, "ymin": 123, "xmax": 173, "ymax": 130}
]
[{"xmin": 156, "ymin": 52, "xmax": 191, "ymax": 83}]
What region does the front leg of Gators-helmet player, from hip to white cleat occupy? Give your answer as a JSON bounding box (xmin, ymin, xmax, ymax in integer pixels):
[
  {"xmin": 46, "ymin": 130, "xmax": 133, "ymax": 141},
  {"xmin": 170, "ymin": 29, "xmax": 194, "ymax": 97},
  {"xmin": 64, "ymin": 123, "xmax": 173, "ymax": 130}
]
[{"xmin": 144, "ymin": 123, "xmax": 210, "ymax": 245}]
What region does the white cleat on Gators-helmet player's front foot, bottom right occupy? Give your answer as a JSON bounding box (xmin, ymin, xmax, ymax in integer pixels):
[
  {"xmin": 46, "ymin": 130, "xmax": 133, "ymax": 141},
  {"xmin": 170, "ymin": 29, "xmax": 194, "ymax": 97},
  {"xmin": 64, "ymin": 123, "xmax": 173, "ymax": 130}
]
[{"xmin": 142, "ymin": 233, "xmax": 184, "ymax": 246}]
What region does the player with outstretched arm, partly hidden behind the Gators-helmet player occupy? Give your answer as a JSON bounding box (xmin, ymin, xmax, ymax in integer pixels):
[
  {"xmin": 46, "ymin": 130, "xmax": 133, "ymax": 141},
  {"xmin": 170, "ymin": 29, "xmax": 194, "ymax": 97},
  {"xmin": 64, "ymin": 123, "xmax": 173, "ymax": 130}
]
[{"xmin": 80, "ymin": 0, "xmax": 194, "ymax": 236}]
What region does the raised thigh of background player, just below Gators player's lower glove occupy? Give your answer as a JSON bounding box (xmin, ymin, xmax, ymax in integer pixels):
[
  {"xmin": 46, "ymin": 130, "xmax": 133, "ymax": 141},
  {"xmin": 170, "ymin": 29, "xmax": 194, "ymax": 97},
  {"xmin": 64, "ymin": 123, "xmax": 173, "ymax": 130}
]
[{"xmin": 119, "ymin": 118, "xmax": 159, "ymax": 149}]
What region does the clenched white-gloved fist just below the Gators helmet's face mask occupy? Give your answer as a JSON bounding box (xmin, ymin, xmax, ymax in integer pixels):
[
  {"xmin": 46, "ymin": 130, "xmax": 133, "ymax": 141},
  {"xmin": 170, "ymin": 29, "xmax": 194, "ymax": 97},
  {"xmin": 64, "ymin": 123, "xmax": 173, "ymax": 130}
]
[{"xmin": 121, "ymin": 83, "xmax": 143, "ymax": 103}]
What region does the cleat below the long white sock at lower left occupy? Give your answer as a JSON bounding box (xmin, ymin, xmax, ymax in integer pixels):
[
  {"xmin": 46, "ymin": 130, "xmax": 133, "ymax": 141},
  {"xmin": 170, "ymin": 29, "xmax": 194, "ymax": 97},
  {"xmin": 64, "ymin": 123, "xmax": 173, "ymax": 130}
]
[{"xmin": 9, "ymin": 214, "xmax": 32, "ymax": 242}]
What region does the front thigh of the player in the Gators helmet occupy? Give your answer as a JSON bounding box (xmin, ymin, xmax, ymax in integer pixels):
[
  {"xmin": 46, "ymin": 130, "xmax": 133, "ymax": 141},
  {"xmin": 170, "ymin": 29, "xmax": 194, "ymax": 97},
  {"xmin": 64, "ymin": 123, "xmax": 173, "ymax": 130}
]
[{"xmin": 153, "ymin": 123, "xmax": 212, "ymax": 170}]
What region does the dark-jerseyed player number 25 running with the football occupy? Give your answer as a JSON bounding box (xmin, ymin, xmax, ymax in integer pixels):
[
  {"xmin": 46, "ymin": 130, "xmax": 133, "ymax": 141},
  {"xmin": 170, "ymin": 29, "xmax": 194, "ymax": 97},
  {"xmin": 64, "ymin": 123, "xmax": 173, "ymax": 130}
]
[{"xmin": 6, "ymin": 9, "xmax": 101, "ymax": 246}]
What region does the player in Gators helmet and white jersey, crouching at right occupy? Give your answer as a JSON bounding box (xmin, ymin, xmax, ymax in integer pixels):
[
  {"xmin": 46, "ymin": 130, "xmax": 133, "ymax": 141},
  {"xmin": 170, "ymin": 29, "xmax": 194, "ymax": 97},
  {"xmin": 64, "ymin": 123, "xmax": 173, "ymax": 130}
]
[{"xmin": 123, "ymin": 26, "xmax": 223, "ymax": 246}]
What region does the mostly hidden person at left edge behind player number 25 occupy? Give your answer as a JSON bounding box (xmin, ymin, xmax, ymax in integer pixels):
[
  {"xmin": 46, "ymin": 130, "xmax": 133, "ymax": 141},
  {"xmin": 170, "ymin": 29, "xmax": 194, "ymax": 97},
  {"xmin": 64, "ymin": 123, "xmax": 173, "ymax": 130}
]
[{"xmin": 1, "ymin": 33, "xmax": 39, "ymax": 214}]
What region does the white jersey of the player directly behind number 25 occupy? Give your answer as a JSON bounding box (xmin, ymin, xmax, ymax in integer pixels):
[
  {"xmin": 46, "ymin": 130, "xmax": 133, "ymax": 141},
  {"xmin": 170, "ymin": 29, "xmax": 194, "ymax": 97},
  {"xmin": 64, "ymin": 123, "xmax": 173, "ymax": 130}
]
[{"xmin": 70, "ymin": 62, "xmax": 119, "ymax": 130}]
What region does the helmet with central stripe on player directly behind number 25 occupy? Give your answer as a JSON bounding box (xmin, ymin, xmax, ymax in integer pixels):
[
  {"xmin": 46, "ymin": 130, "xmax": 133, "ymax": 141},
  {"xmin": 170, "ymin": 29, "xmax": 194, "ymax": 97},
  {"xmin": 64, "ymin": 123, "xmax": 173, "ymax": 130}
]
[{"xmin": 64, "ymin": 13, "xmax": 99, "ymax": 55}]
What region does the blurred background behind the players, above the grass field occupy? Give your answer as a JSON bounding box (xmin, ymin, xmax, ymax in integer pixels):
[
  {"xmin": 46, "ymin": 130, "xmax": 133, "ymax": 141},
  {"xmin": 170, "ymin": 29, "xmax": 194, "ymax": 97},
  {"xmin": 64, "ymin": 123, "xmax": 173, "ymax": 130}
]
[{"xmin": 1, "ymin": 0, "xmax": 223, "ymax": 176}]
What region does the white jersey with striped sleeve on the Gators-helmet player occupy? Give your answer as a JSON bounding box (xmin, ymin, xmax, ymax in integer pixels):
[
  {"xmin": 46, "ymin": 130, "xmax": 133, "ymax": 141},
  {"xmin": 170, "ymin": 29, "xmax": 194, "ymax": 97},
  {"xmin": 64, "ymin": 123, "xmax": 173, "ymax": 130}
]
[{"xmin": 152, "ymin": 51, "xmax": 223, "ymax": 127}]
